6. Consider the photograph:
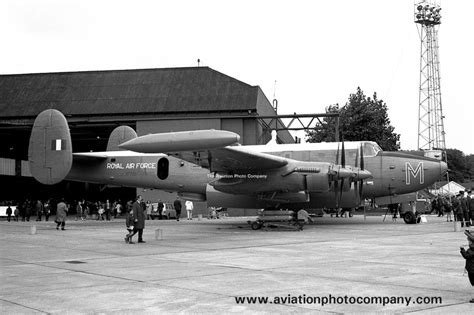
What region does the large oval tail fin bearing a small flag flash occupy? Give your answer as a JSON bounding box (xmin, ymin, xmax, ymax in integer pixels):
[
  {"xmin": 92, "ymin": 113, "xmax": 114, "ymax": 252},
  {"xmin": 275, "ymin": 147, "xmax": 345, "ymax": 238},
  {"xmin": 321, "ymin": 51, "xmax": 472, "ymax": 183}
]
[{"xmin": 28, "ymin": 109, "xmax": 72, "ymax": 185}]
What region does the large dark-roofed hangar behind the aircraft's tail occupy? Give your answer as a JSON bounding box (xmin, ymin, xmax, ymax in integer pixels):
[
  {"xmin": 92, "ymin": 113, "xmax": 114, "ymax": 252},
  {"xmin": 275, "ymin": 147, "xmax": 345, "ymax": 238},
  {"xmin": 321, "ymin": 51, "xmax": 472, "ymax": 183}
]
[{"xmin": 0, "ymin": 67, "xmax": 294, "ymax": 209}]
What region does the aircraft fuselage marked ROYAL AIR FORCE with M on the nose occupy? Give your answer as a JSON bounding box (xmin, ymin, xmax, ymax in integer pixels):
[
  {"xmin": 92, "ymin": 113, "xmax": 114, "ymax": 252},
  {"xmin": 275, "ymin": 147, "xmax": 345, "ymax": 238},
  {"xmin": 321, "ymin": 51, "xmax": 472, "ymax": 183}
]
[{"xmin": 66, "ymin": 144, "xmax": 446, "ymax": 208}]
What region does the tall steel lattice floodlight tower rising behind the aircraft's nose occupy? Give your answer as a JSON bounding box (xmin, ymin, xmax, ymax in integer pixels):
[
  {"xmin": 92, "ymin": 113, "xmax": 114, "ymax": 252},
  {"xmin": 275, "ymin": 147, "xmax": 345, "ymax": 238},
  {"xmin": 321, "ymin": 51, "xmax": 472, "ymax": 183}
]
[{"xmin": 415, "ymin": 0, "xmax": 446, "ymax": 151}]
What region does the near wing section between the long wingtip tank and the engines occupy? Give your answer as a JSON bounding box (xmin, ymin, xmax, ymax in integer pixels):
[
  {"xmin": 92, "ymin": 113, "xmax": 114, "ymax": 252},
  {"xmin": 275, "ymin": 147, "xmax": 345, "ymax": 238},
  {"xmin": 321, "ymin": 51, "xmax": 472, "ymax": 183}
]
[{"xmin": 172, "ymin": 146, "xmax": 288, "ymax": 172}]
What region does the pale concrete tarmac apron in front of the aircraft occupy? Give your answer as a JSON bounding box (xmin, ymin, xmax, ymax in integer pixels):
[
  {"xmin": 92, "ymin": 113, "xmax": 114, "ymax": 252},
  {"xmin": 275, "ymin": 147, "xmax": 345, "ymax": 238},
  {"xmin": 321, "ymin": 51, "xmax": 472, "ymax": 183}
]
[{"xmin": 0, "ymin": 215, "xmax": 474, "ymax": 314}]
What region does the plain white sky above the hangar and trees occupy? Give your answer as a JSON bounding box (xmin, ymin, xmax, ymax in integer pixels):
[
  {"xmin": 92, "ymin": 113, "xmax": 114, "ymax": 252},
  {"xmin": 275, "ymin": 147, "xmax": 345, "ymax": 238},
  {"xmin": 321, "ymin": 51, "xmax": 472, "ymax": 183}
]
[{"xmin": 0, "ymin": 0, "xmax": 474, "ymax": 155}]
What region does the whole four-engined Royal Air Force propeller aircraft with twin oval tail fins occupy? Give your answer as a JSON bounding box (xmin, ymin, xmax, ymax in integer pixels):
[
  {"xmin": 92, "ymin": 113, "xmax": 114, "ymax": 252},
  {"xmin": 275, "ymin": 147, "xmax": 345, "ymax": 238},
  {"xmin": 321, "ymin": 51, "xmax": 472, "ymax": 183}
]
[{"xmin": 28, "ymin": 109, "xmax": 447, "ymax": 209}]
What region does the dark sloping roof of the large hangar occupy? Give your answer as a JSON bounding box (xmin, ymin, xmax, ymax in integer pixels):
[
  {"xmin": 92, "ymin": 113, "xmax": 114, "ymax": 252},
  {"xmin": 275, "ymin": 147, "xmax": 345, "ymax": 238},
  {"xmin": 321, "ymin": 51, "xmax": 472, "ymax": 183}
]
[{"xmin": 0, "ymin": 67, "xmax": 262, "ymax": 118}]
